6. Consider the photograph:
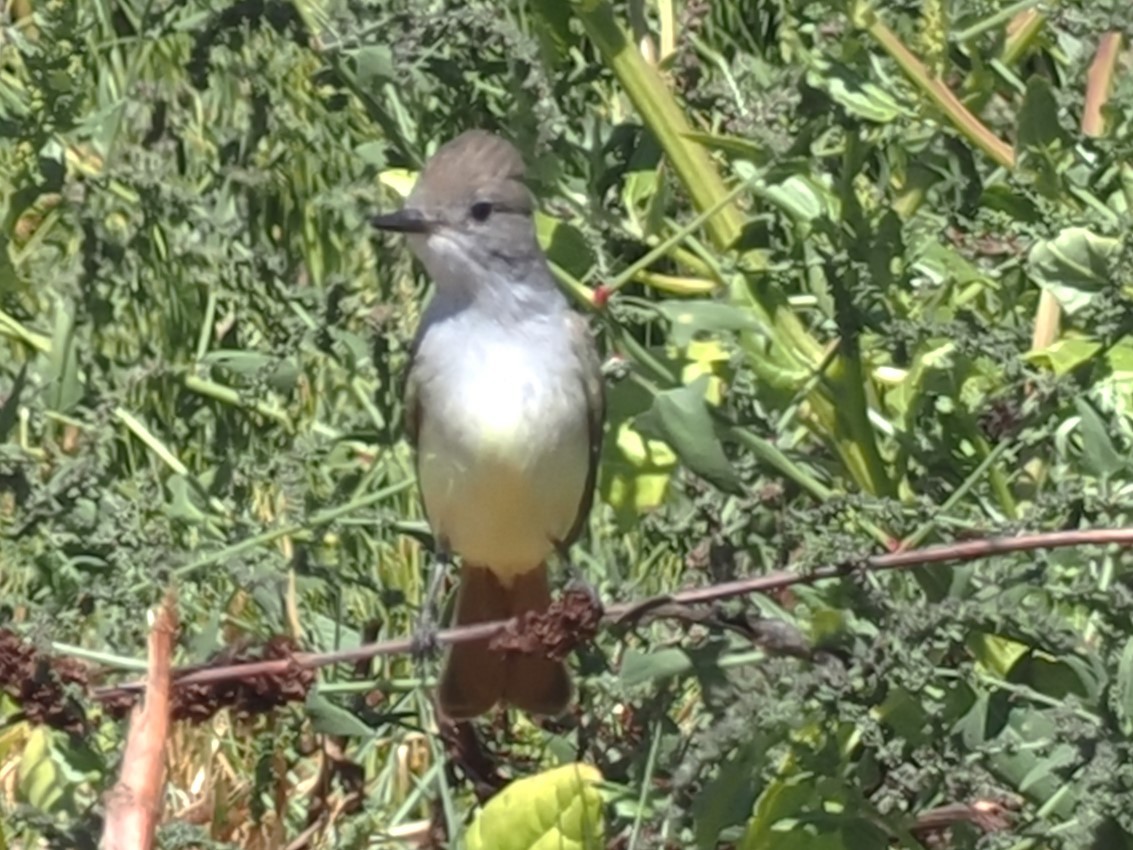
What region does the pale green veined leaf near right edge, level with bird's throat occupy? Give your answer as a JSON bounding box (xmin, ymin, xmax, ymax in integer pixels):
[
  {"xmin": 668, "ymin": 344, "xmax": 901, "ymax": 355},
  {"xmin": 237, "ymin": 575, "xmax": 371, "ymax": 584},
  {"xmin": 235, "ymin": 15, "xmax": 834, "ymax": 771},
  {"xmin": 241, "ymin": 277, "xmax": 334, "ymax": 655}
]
[{"xmin": 1028, "ymin": 227, "xmax": 1122, "ymax": 315}]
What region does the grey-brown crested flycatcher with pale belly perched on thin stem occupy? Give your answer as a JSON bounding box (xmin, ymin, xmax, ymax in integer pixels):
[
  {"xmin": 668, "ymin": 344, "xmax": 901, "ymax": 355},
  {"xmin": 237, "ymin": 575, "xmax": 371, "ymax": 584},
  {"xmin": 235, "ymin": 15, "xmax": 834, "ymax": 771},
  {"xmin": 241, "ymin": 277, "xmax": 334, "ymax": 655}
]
[{"xmin": 372, "ymin": 130, "xmax": 605, "ymax": 720}]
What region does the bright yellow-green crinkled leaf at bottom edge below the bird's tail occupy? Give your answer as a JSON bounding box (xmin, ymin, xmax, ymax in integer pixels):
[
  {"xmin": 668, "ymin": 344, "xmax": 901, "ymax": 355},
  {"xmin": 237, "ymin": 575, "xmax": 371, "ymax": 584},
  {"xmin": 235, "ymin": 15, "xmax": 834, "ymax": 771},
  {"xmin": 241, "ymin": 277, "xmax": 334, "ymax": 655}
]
[{"xmin": 466, "ymin": 763, "xmax": 606, "ymax": 850}]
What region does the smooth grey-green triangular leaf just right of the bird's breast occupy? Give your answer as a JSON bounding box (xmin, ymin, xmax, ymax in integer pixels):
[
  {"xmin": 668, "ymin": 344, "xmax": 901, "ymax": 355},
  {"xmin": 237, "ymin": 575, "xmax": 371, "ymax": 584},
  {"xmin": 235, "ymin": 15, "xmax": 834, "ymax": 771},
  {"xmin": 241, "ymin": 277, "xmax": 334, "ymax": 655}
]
[{"xmin": 637, "ymin": 375, "xmax": 743, "ymax": 493}]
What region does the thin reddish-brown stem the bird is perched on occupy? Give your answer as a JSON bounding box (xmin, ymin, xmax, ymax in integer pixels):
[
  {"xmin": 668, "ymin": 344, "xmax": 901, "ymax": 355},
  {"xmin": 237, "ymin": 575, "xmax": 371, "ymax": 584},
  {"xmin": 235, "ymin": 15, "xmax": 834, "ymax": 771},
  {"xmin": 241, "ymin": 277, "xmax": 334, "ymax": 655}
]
[{"xmin": 93, "ymin": 527, "xmax": 1133, "ymax": 700}]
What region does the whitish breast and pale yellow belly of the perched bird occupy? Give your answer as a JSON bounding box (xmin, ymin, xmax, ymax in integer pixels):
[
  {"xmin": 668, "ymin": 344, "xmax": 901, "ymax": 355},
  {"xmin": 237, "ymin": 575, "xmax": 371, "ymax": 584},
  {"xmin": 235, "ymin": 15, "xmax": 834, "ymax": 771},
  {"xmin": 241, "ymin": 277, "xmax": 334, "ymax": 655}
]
[{"xmin": 418, "ymin": 322, "xmax": 589, "ymax": 576}]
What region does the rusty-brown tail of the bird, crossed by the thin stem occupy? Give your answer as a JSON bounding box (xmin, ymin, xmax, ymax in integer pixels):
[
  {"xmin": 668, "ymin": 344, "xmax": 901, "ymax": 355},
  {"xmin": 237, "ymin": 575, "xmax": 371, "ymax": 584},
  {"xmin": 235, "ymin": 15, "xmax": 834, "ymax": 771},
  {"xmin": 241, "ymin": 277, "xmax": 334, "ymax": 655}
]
[{"xmin": 438, "ymin": 564, "xmax": 571, "ymax": 720}]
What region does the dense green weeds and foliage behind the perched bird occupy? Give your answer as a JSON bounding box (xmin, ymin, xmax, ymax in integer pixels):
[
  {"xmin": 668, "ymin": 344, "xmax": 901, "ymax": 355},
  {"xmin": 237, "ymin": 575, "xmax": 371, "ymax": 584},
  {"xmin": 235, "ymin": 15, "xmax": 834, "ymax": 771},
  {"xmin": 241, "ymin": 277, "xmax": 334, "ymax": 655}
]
[{"xmin": 0, "ymin": 0, "xmax": 1133, "ymax": 850}]
